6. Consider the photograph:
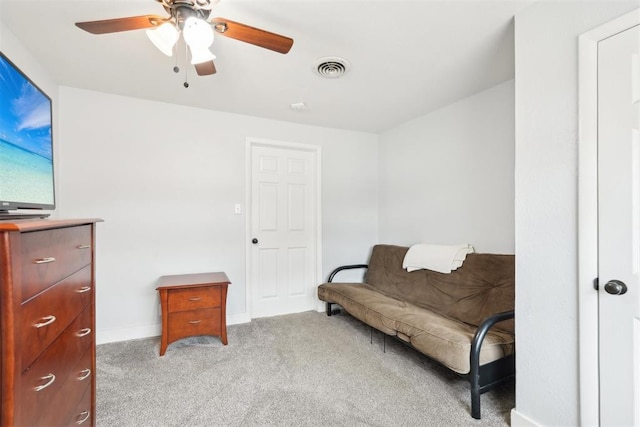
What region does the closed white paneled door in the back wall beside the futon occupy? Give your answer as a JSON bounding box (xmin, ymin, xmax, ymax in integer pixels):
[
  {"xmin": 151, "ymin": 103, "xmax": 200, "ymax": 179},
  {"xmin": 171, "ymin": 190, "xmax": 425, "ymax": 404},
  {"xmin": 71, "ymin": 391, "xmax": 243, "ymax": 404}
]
[{"xmin": 249, "ymin": 144, "xmax": 318, "ymax": 317}]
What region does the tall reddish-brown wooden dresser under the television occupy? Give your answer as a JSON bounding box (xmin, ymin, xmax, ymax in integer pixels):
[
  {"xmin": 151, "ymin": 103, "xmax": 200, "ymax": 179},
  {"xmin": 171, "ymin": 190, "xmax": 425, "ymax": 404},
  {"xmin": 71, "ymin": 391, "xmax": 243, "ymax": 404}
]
[{"xmin": 0, "ymin": 219, "xmax": 100, "ymax": 427}]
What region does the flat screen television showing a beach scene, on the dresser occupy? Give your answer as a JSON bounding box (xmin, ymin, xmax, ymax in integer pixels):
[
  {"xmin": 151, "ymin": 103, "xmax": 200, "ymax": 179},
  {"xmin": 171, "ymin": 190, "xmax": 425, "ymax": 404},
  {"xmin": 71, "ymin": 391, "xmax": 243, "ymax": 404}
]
[{"xmin": 0, "ymin": 52, "xmax": 55, "ymax": 219}]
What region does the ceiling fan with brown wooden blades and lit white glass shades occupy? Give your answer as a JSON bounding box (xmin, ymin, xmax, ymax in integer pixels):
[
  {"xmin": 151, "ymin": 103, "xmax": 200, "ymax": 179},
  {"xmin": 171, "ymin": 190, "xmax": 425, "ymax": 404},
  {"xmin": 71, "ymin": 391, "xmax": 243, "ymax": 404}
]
[{"xmin": 76, "ymin": 0, "xmax": 293, "ymax": 76}]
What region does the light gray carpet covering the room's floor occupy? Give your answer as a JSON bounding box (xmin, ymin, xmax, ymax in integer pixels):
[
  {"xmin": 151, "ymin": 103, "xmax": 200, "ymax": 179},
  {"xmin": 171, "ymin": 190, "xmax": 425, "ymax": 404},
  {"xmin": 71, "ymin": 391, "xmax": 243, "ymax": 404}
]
[{"xmin": 96, "ymin": 312, "xmax": 515, "ymax": 427}]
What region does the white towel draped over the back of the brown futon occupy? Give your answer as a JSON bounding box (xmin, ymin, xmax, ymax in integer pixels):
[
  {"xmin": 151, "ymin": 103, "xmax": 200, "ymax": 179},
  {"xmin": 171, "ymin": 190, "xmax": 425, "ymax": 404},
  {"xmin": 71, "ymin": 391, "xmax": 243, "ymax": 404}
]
[{"xmin": 402, "ymin": 243, "xmax": 475, "ymax": 273}]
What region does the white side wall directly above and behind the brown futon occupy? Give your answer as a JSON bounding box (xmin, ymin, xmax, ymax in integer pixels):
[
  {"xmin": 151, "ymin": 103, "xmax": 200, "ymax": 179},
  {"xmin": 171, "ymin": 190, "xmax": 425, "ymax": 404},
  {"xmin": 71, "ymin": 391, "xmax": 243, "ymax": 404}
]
[{"xmin": 379, "ymin": 80, "xmax": 515, "ymax": 253}]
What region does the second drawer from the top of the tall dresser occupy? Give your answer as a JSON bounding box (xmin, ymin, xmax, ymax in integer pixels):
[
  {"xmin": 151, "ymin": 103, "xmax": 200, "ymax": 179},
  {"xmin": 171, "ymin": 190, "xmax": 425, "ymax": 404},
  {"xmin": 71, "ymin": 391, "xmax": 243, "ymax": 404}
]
[{"xmin": 17, "ymin": 266, "xmax": 93, "ymax": 370}]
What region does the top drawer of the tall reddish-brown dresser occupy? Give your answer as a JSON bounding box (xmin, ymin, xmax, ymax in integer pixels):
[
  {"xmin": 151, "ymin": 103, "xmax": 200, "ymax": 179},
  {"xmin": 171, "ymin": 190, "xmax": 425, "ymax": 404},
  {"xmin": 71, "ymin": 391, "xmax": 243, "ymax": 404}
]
[{"xmin": 21, "ymin": 225, "xmax": 92, "ymax": 301}]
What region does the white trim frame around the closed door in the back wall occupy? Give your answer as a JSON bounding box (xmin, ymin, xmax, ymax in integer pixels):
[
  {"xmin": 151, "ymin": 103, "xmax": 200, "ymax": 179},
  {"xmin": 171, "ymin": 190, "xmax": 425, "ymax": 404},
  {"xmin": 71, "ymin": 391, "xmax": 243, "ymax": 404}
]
[{"xmin": 244, "ymin": 137, "xmax": 322, "ymax": 319}]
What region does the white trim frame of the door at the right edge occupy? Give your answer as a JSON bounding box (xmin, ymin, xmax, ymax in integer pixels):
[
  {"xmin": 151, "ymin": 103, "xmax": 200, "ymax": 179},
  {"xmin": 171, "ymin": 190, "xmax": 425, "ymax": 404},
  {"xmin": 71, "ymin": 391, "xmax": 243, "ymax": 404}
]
[{"xmin": 578, "ymin": 9, "xmax": 640, "ymax": 425}]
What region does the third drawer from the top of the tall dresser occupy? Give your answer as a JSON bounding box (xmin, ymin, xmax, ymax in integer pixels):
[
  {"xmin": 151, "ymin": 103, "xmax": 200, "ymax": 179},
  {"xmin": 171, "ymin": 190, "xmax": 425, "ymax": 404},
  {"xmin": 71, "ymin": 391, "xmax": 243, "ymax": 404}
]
[{"xmin": 19, "ymin": 306, "xmax": 94, "ymax": 426}]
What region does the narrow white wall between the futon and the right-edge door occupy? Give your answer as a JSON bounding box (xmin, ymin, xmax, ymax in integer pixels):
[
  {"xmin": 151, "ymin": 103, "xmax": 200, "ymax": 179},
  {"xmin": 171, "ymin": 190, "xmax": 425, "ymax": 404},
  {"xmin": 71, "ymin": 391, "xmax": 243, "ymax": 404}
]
[{"xmin": 512, "ymin": 0, "xmax": 640, "ymax": 426}]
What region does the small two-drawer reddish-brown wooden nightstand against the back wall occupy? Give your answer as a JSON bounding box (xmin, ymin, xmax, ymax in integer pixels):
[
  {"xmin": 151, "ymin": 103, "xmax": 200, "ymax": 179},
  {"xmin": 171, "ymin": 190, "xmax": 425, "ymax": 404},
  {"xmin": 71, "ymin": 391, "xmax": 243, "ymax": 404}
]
[{"xmin": 157, "ymin": 272, "xmax": 231, "ymax": 356}]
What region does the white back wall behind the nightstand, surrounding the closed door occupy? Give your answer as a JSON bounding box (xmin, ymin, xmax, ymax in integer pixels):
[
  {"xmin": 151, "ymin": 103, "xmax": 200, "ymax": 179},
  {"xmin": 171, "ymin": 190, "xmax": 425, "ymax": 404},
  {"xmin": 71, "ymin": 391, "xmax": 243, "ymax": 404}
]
[{"xmin": 58, "ymin": 87, "xmax": 378, "ymax": 342}]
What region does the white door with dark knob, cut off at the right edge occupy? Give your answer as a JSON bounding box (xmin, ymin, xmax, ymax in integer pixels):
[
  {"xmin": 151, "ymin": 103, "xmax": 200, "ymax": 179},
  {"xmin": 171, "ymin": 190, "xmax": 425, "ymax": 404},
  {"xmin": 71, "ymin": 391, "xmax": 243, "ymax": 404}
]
[{"xmin": 598, "ymin": 26, "xmax": 640, "ymax": 426}]
